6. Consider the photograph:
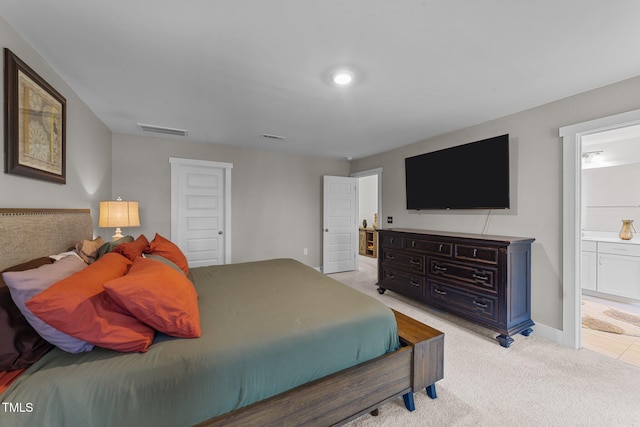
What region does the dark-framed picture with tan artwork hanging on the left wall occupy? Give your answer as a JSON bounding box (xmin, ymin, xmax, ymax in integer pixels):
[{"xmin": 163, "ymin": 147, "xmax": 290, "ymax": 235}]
[{"xmin": 4, "ymin": 48, "xmax": 67, "ymax": 184}]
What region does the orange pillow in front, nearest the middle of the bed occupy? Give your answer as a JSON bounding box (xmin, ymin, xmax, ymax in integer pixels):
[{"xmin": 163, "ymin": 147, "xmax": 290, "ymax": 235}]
[{"xmin": 104, "ymin": 257, "xmax": 201, "ymax": 338}]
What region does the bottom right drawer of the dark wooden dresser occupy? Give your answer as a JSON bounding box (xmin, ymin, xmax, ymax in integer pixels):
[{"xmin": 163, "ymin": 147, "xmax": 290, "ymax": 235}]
[{"xmin": 427, "ymin": 280, "xmax": 498, "ymax": 323}]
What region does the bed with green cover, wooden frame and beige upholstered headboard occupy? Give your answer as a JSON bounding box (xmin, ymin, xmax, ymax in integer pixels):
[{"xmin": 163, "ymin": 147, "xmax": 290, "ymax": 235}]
[{"xmin": 0, "ymin": 209, "xmax": 442, "ymax": 426}]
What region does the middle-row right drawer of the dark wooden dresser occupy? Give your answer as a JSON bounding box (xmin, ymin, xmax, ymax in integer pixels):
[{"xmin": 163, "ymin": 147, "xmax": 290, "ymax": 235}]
[{"xmin": 428, "ymin": 258, "xmax": 498, "ymax": 294}]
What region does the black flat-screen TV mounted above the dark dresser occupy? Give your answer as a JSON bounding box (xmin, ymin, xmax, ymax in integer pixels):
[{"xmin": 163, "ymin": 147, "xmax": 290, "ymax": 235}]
[{"xmin": 405, "ymin": 134, "xmax": 510, "ymax": 210}]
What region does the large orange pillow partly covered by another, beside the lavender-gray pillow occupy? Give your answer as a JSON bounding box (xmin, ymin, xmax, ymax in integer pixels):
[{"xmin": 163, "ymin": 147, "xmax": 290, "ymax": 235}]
[{"xmin": 26, "ymin": 252, "xmax": 155, "ymax": 351}]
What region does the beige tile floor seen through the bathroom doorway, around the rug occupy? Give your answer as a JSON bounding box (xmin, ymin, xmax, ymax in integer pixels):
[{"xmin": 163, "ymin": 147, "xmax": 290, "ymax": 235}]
[{"xmin": 582, "ymin": 295, "xmax": 640, "ymax": 366}]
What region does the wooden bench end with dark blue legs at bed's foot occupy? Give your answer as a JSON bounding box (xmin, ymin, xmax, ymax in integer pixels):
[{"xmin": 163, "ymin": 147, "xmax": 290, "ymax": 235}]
[{"xmin": 393, "ymin": 310, "xmax": 444, "ymax": 411}]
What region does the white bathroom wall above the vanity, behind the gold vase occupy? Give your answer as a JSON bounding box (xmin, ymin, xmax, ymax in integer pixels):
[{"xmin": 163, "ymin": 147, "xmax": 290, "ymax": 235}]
[{"xmin": 582, "ymin": 163, "xmax": 640, "ymax": 232}]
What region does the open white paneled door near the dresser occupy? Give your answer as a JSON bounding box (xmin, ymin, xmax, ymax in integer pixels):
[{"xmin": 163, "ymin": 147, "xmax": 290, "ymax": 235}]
[{"xmin": 322, "ymin": 176, "xmax": 358, "ymax": 274}]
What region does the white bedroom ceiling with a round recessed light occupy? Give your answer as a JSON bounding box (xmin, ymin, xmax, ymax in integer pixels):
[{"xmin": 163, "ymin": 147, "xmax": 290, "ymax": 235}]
[{"xmin": 0, "ymin": 0, "xmax": 640, "ymax": 159}]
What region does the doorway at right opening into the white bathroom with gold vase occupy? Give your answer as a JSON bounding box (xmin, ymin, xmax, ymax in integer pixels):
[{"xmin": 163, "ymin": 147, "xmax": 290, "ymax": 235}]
[{"xmin": 579, "ymin": 129, "xmax": 640, "ymax": 366}]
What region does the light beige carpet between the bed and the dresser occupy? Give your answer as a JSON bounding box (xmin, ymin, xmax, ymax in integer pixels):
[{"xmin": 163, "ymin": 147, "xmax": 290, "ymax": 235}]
[{"xmin": 330, "ymin": 259, "xmax": 640, "ymax": 427}]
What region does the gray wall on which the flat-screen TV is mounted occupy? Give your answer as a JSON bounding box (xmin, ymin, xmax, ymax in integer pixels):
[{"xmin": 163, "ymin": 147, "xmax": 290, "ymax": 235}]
[{"xmin": 351, "ymin": 77, "xmax": 640, "ymax": 330}]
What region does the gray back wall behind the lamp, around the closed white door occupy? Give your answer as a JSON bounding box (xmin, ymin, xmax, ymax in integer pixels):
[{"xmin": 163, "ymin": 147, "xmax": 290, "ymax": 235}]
[{"xmin": 110, "ymin": 134, "xmax": 349, "ymax": 267}]
